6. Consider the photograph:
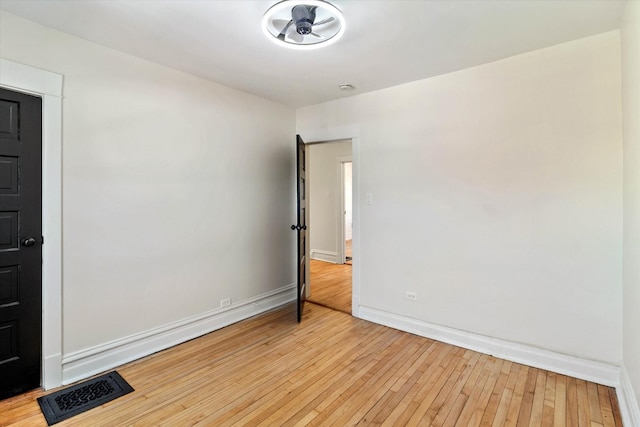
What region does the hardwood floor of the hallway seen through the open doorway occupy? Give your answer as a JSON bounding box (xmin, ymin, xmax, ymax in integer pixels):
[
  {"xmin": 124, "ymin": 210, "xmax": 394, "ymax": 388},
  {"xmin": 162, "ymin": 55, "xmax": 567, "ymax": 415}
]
[{"xmin": 308, "ymin": 259, "xmax": 353, "ymax": 314}]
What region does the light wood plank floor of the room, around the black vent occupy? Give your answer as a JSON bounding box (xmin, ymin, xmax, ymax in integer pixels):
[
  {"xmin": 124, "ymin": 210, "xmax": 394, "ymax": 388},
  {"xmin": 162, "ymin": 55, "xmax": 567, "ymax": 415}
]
[{"xmin": 0, "ymin": 303, "xmax": 622, "ymax": 427}]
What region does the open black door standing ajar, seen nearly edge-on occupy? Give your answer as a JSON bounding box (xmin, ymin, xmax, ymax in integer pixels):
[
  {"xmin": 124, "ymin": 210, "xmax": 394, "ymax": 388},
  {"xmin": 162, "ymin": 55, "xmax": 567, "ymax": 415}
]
[{"xmin": 291, "ymin": 135, "xmax": 307, "ymax": 322}]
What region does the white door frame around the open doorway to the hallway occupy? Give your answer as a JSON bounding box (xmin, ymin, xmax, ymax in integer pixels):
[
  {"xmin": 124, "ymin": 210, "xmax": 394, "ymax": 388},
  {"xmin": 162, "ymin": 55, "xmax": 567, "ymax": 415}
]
[{"xmin": 297, "ymin": 125, "xmax": 366, "ymax": 317}]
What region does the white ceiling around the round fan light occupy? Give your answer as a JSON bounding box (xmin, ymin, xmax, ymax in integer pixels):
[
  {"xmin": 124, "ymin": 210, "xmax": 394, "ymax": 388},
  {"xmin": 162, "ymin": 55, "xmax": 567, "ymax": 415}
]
[{"xmin": 0, "ymin": 0, "xmax": 636, "ymax": 107}]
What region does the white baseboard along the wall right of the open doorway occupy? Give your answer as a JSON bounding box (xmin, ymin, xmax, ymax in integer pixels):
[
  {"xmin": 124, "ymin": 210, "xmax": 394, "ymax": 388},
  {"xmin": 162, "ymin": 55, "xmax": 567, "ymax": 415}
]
[{"xmin": 359, "ymin": 306, "xmax": 620, "ymax": 387}]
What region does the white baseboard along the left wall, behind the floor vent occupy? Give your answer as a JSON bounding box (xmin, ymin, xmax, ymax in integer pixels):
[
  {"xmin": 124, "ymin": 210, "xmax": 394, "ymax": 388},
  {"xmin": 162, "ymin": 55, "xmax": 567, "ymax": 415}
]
[{"xmin": 62, "ymin": 285, "xmax": 296, "ymax": 385}]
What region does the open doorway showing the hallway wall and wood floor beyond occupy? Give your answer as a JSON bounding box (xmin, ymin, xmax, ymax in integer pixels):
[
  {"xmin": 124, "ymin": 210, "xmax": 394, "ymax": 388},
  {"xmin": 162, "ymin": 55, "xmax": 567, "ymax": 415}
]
[{"xmin": 306, "ymin": 139, "xmax": 353, "ymax": 314}]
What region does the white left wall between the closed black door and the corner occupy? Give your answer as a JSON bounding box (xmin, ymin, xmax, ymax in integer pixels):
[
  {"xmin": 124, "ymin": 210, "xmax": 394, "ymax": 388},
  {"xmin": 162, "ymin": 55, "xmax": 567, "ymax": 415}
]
[{"xmin": 0, "ymin": 13, "xmax": 295, "ymax": 362}]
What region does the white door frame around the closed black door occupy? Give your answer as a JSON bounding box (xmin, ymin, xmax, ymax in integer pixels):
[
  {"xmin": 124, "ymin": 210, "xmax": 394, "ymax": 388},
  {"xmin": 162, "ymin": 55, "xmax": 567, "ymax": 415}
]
[{"xmin": 0, "ymin": 58, "xmax": 62, "ymax": 389}]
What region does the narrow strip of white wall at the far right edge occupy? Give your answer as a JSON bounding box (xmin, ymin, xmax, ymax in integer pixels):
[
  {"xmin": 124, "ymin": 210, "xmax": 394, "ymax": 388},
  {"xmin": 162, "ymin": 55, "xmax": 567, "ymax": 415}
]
[{"xmin": 622, "ymin": 1, "xmax": 640, "ymax": 425}]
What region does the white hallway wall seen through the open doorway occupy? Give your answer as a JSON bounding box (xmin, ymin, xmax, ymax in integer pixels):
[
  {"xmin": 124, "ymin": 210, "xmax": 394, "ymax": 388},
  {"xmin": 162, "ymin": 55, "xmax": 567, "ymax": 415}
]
[{"xmin": 307, "ymin": 140, "xmax": 351, "ymax": 262}]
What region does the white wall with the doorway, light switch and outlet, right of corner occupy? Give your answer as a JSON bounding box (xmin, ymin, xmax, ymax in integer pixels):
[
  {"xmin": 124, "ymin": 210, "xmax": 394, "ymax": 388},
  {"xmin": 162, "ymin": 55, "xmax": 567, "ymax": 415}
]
[{"xmin": 297, "ymin": 31, "xmax": 622, "ymax": 365}]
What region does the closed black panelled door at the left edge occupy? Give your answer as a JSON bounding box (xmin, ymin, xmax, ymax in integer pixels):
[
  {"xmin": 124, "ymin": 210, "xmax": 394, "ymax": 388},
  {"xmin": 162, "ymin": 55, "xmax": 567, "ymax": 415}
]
[{"xmin": 0, "ymin": 89, "xmax": 42, "ymax": 398}]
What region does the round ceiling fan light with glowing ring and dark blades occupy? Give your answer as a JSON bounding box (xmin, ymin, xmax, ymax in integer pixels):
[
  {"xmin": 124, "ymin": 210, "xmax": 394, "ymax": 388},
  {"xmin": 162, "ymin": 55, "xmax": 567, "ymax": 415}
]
[{"xmin": 262, "ymin": 0, "xmax": 345, "ymax": 49}]
